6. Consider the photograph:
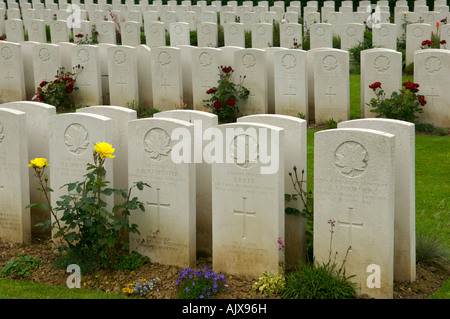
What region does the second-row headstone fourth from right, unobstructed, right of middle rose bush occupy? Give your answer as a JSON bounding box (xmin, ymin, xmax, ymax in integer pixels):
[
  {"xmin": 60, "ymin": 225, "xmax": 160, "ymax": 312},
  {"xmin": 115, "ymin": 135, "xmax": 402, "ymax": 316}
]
[{"xmin": 274, "ymin": 50, "xmax": 309, "ymax": 120}]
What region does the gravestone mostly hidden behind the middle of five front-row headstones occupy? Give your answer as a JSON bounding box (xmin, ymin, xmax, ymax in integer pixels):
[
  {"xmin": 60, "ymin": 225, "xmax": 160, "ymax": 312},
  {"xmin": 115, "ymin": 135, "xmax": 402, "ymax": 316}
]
[{"xmin": 153, "ymin": 110, "xmax": 218, "ymax": 255}]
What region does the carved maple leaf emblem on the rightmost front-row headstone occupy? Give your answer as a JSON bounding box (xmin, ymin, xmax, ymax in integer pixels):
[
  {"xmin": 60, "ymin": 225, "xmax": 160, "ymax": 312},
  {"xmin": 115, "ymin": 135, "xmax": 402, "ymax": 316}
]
[{"xmin": 335, "ymin": 142, "xmax": 368, "ymax": 177}]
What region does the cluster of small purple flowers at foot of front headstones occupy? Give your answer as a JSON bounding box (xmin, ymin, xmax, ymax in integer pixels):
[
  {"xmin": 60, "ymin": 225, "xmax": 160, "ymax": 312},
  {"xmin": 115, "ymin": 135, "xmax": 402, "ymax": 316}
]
[{"xmin": 175, "ymin": 267, "xmax": 230, "ymax": 299}]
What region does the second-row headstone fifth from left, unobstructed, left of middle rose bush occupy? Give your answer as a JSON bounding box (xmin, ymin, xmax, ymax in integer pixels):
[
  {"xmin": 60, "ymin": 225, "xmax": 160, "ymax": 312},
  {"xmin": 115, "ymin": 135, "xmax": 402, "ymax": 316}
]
[{"xmin": 151, "ymin": 47, "xmax": 183, "ymax": 111}]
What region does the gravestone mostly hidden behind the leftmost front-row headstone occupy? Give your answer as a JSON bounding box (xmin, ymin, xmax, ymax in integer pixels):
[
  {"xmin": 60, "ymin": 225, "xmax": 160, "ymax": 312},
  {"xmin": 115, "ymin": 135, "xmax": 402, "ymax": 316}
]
[{"xmin": 0, "ymin": 101, "xmax": 56, "ymax": 240}]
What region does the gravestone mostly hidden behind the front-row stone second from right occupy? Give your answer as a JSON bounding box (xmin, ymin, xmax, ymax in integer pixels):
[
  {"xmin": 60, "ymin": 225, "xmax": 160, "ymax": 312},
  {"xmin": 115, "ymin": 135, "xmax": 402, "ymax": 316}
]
[{"xmin": 237, "ymin": 114, "xmax": 307, "ymax": 266}]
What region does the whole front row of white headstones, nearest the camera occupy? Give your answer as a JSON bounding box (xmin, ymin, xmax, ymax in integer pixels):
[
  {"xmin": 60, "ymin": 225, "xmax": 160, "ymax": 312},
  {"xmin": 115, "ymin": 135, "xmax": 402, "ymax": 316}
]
[{"xmin": 0, "ymin": 102, "xmax": 415, "ymax": 298}]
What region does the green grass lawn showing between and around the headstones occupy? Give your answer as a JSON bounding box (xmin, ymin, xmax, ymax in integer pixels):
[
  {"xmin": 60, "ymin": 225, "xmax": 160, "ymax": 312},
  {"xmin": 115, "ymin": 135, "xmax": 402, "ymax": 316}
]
[{"xmin": 0, "ymin": 75, "xmax": 450, "ymax": 299}]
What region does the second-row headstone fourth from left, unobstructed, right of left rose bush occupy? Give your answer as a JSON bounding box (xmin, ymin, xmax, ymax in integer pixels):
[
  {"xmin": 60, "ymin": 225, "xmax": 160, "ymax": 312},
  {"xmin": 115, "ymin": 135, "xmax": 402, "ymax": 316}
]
[{"xmin": 107, "ymin": 45, "xmax": 139, "ymax": 106}]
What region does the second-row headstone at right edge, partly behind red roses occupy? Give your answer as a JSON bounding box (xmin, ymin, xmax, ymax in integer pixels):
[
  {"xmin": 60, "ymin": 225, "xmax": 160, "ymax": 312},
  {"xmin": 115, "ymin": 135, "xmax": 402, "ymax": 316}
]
[{"xmin": 414, "ymin": 49, "xmax": 450, "ymax": 128}]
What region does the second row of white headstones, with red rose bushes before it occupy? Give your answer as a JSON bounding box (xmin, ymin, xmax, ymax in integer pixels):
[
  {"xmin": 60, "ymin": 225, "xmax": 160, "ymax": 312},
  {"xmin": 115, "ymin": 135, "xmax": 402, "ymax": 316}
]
[{"xmin": 0, "ymin": 41, "xmax": 450, "ymax": 127}]
